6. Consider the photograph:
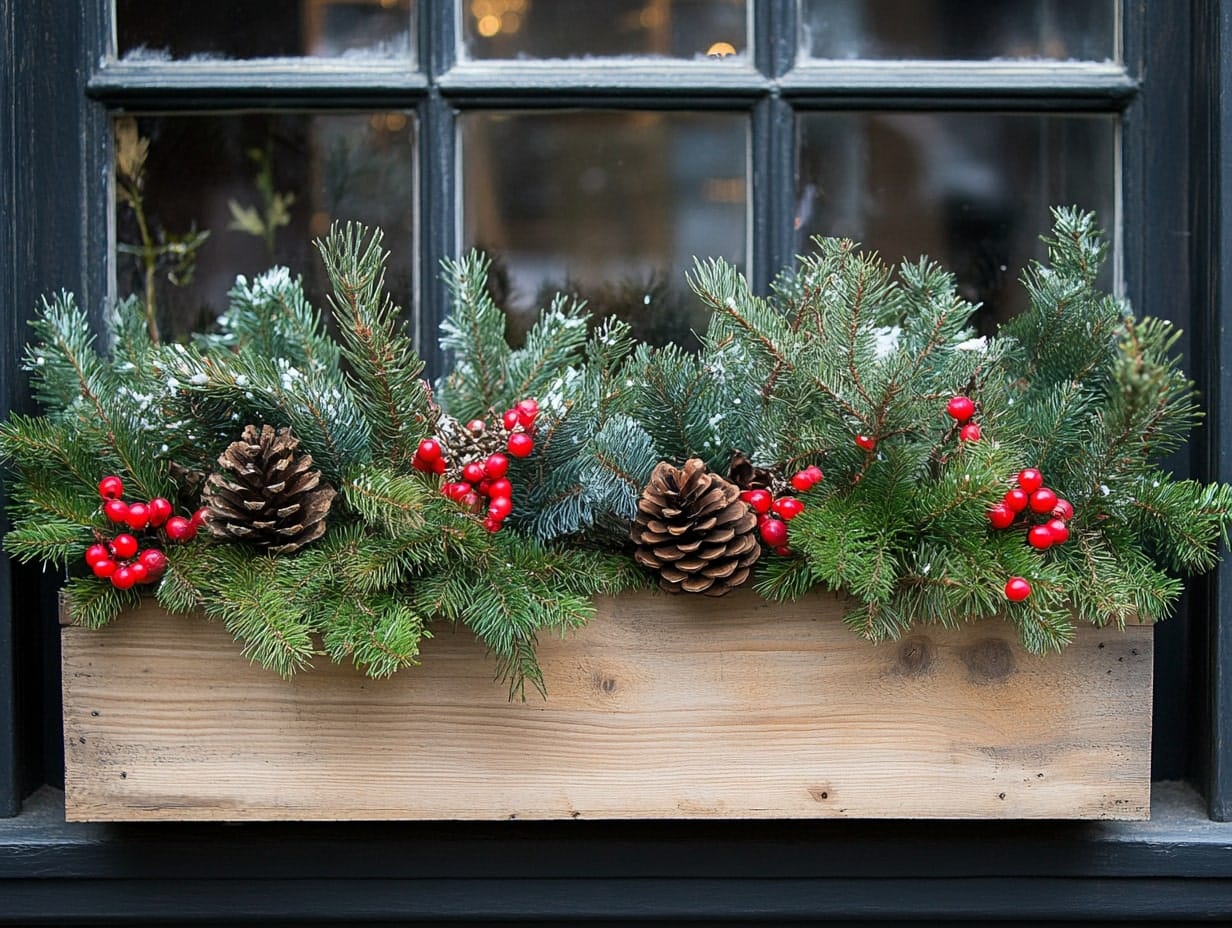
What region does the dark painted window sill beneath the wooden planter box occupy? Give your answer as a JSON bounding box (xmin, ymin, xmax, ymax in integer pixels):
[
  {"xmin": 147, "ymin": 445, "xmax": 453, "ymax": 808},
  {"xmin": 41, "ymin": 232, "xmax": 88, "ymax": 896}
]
[{"xmin": 0, "ymin": 783, "xmax": 1232, "ymax": 923}]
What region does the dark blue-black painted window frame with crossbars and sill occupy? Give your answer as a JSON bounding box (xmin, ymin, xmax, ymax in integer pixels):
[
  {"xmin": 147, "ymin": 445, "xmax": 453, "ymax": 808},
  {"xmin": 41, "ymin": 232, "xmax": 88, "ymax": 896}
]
[{"xmin": 0, "ymin": 0, "xmax": 1232, "ymax": 924}]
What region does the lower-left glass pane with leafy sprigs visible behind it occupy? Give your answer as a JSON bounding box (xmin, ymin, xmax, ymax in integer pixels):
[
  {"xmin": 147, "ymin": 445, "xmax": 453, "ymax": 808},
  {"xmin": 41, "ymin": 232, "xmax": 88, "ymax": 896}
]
[{"xmin": 116, "ymin": 112, "xmax": 415, "ymax": 339}]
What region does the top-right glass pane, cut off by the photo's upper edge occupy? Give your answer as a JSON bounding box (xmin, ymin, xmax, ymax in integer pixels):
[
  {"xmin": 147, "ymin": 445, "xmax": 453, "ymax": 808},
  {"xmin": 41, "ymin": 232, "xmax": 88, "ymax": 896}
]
[{"xmin": 801, "ymin": 0, "xmax": 1116, "ymax": 62}]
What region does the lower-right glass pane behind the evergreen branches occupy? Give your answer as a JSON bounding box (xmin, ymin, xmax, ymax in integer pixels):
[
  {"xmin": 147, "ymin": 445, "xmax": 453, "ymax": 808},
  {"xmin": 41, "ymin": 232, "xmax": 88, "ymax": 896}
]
[{"xmin": 795, "ymin": 112, "xmax": 1117, "ymax": 325}]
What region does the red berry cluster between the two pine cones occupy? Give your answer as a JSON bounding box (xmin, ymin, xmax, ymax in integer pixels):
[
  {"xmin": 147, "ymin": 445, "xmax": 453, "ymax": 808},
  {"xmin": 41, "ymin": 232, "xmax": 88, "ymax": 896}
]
[{"xmin": 411, "ymin": 399, "xmax": 538, "ymax": 532}]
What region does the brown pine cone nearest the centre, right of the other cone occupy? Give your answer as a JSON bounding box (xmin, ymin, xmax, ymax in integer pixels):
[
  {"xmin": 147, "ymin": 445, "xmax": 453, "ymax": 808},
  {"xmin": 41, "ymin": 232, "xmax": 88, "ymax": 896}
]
[{"xmin": 630, "ymin": 457, "xmax": 761, "ymax": 596}]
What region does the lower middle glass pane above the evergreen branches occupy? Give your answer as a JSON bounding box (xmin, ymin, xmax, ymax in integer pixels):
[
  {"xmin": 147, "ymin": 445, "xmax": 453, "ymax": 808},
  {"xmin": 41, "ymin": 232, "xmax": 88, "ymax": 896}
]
[{"xmin": 461, "ymin": 111, "xmax": 749, "ymax": 344}]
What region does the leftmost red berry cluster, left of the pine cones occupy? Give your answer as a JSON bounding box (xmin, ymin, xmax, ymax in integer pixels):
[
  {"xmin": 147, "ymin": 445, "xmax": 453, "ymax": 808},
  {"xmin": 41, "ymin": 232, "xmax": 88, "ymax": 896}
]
[{"xmin": 85, "ymin": 476, "xmax": 206, "ymax": 589}]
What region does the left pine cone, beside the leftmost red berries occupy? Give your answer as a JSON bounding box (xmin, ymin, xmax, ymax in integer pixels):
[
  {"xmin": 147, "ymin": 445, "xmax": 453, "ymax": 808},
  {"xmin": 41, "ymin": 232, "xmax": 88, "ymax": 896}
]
[{"xmin": 201, "ymin": 425, "xmax": 335, "ymax": 555}]
